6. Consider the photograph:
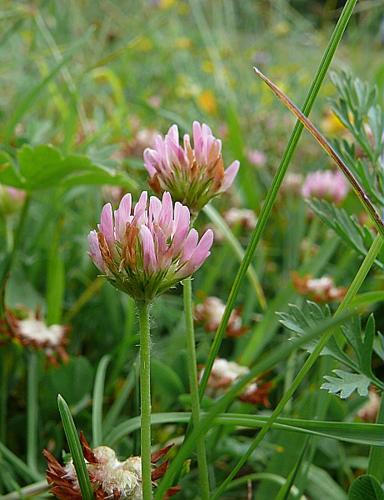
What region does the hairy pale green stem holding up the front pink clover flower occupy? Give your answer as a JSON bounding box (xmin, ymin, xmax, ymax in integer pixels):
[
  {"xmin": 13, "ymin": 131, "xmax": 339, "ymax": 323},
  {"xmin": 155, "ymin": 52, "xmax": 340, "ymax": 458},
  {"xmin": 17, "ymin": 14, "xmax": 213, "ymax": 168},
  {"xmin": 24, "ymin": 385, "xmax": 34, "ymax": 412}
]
[{"xmin": 137, "ymin": 301, "xmax": 152, "ymax": 500}]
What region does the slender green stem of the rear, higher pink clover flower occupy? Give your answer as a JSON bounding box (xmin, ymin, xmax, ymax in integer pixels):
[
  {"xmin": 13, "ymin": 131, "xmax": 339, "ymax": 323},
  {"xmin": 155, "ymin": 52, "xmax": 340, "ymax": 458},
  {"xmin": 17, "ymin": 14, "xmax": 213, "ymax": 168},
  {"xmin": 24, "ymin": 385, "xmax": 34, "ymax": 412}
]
[{"xmin": 183, "ymin": 278, "xmax": 209, "ymax": 500}]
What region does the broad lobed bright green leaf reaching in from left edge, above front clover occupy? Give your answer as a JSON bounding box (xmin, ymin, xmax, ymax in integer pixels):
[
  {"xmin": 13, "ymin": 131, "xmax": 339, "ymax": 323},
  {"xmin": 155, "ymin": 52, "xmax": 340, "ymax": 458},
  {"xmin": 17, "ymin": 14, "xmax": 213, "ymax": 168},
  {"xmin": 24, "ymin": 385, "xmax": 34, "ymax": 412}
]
[{"xmin": 0, "ymin": 144, "xmax": 137, "ymax": 191}]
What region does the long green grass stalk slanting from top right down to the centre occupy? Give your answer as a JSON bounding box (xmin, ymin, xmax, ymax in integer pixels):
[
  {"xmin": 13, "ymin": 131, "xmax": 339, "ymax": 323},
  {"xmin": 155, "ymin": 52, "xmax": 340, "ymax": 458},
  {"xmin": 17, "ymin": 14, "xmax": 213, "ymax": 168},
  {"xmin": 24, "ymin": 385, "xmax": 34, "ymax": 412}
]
[{"xmin": 200, "ymin": 0, "xmax": 357, "ymax": 397}]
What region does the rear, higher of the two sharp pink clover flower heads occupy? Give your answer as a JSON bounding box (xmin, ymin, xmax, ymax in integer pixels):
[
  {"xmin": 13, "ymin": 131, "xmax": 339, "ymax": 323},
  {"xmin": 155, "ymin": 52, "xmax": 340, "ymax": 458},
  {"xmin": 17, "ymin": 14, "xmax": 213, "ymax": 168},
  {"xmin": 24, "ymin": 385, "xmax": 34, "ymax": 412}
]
[{"xmin": 144, "ymin": 121, "xmax": 240, "ymax": 214}]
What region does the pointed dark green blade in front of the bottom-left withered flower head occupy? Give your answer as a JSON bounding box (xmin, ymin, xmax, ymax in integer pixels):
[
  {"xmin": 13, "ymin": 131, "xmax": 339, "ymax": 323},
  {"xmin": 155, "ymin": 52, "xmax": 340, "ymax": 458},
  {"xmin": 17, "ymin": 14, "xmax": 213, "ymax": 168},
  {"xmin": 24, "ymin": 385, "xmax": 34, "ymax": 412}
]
[{"xmin": 57, "ymin": 394, "xmax": 94, "ymax": 500}]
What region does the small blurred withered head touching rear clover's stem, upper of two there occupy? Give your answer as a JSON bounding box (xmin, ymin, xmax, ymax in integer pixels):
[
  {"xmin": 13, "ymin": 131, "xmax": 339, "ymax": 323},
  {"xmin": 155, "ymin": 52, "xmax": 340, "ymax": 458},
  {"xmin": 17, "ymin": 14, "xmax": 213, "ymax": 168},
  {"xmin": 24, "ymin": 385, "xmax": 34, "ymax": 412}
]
[{"xmin": 194, "ymin": 297, "xmax": 247, "ymax": 337}]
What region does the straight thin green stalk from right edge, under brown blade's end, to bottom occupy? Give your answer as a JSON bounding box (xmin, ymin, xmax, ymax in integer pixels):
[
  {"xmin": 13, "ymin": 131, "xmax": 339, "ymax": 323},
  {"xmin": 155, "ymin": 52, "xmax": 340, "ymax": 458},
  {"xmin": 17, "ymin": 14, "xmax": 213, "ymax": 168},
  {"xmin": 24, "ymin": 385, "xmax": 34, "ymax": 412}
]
[{"xmin": 212, "ymin": 235, "xmax": 383, "ymax": 500}]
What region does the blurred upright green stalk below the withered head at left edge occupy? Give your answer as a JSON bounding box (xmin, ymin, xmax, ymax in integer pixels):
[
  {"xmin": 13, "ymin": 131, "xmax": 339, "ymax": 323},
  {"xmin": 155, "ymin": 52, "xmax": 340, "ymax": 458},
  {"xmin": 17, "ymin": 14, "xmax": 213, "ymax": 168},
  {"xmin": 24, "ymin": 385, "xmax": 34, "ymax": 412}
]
[{"xmin": 27, "ymin": 352, "xmax": 39, "ymax": 472}]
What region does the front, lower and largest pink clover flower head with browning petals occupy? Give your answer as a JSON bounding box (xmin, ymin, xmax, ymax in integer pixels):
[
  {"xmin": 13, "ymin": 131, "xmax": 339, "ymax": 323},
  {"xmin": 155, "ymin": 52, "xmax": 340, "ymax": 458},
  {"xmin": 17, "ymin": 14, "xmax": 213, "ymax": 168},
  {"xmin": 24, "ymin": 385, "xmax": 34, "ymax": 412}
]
[{"xmin": 88, "ymin": 191, "xmax": 213, "ymax": 301}]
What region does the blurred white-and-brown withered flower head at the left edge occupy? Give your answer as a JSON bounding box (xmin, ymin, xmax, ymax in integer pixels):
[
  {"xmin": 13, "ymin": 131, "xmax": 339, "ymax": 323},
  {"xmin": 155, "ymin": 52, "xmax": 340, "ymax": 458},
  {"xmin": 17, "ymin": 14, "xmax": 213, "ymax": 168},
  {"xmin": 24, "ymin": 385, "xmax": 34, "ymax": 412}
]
[{"xmin": 0, "ymin": 309, "xmax": 70, "ymax": 364}]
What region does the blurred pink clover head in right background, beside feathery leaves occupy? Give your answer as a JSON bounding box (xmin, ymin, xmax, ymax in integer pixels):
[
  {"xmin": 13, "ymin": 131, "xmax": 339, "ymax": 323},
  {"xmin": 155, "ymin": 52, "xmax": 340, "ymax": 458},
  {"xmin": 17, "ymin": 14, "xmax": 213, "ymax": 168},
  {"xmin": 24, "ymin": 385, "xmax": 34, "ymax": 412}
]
[{"xmin": 301, "ymin": 170, "xmax": 349, "ymax": 204}]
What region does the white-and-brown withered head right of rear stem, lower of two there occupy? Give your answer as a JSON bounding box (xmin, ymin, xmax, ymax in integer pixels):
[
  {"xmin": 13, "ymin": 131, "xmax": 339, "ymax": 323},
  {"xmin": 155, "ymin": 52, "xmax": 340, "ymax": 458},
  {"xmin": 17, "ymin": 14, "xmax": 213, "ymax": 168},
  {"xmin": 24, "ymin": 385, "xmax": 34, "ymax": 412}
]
[{"xmin": 201, "ymin": 358, "xmax": 272, "ymax": 408}]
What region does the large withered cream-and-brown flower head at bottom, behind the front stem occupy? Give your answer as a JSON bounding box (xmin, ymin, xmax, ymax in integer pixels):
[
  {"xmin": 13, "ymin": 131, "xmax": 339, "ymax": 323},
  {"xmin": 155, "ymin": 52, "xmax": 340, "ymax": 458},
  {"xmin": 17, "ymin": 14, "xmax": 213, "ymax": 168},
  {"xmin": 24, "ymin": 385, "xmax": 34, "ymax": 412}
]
[{"xmin": 43, "ymin": 433, "xmax": 180, "ymax": 500}]
